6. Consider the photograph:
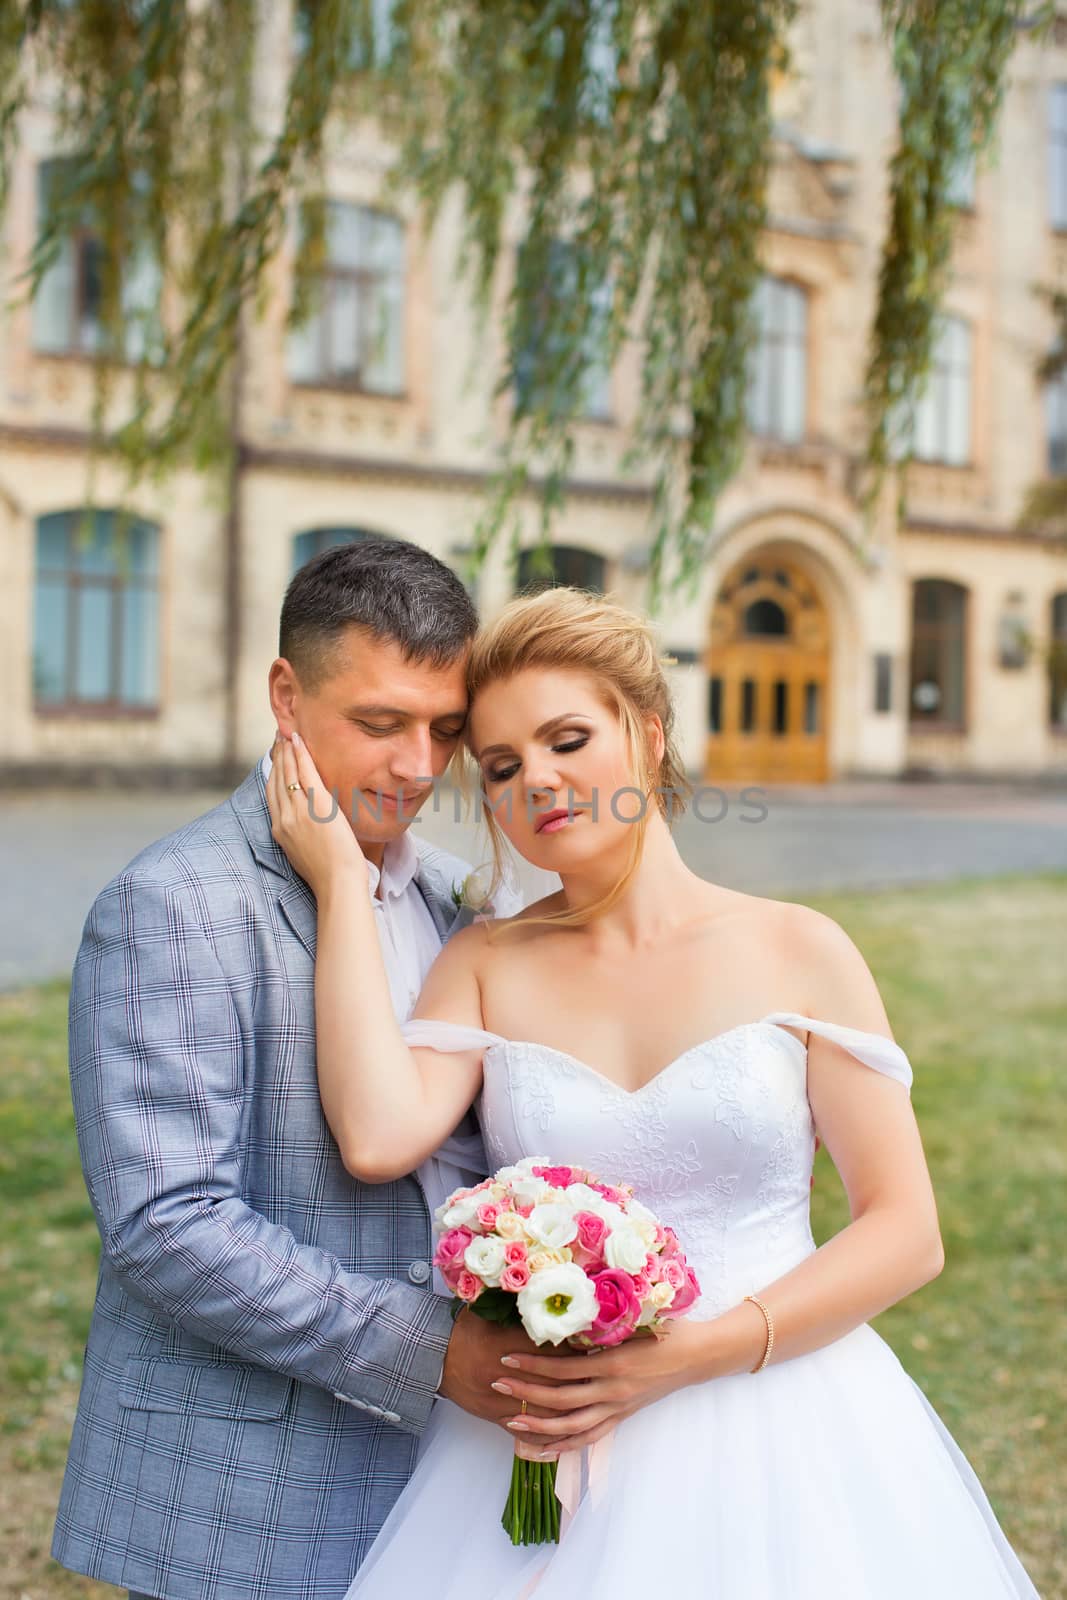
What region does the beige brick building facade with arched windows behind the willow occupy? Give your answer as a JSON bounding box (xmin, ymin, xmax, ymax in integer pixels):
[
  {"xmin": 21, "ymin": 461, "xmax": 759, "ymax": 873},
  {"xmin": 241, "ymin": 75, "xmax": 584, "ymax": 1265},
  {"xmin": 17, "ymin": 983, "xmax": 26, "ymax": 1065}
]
[{"xmin": 0, "ymin": 0, "xmax": 1067, "ymax": 782}]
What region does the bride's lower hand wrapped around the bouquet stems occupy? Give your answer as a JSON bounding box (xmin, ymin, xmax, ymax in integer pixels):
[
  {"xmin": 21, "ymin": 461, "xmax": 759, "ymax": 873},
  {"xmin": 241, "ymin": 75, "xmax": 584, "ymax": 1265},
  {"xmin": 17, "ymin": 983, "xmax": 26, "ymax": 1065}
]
[{"xmin": 493, "ymin": 1322, "xmax": 710, "ymax": 1459}]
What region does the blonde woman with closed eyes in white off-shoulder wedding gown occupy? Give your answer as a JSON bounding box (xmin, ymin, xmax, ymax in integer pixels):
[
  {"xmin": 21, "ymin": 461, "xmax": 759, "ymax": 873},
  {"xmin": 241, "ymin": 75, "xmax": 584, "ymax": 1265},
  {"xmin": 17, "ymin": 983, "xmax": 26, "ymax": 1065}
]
[{"xmin": 270, "ymin": 589, "xmax": 1037, "ymax": 1600}]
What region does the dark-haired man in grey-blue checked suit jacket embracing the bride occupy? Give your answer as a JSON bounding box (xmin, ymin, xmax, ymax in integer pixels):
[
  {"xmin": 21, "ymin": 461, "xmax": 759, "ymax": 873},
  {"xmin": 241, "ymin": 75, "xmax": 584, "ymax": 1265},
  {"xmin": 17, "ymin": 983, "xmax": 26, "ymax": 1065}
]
[{"xmin": 53, "ymin": 539, "xmax": 531, "ymax": 1600}]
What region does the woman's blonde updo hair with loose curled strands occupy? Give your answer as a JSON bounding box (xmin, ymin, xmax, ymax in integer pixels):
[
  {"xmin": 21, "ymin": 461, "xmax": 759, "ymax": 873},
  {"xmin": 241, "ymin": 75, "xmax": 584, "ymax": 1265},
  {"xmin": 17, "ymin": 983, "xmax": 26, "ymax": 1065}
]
[{"xmin": 467, "ymin": 587, "xmax": 693, "ymax": 931}]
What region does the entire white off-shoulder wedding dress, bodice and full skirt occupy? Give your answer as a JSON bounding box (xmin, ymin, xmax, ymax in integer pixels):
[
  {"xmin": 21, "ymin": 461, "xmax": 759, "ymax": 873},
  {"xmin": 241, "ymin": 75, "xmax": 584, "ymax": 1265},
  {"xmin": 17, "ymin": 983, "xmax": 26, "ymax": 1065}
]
[{"xmin": 347, "ymin": 1011, "xmax": 1037, "ymax": 1600}]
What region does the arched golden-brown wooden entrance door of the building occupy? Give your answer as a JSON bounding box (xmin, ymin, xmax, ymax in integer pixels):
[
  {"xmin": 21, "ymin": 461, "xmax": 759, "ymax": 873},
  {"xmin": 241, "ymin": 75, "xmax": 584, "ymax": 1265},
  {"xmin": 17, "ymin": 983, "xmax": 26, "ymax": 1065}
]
[{"xmin": 704, "ymin": 555, "xmax": 830, "ymax": 784}]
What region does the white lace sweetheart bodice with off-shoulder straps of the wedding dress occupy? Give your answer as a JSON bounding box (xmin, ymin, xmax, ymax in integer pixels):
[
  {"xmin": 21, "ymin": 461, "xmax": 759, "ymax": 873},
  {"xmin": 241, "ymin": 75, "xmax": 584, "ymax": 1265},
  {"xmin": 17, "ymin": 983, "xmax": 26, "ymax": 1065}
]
[{"xmin": 403, "ymin": 1011, "xmax": 912, "ymax": 1317}]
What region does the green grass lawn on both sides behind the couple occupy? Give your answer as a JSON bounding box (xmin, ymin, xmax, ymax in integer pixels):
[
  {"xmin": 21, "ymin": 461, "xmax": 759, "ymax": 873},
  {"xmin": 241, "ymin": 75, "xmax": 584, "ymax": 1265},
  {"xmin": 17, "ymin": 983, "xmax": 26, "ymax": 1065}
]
[{"xmin": 0, "ymin": 875, "xmax": 1067, "ymax": 1600}]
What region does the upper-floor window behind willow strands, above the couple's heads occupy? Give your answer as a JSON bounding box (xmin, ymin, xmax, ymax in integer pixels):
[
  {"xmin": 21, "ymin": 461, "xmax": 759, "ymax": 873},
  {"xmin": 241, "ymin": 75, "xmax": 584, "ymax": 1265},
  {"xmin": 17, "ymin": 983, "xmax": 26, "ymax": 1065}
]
[{"xmin": 512, "ymin": 238, "xmax": 613, "ymax": 421}]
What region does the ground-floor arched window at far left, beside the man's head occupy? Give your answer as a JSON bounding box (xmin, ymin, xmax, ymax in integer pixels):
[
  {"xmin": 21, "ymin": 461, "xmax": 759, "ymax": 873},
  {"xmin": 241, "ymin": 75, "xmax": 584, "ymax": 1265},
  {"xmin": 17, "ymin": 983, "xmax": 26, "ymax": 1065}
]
[{"xmin": 34, "ymin": 510, "xmax": 160, "ymax": 710}]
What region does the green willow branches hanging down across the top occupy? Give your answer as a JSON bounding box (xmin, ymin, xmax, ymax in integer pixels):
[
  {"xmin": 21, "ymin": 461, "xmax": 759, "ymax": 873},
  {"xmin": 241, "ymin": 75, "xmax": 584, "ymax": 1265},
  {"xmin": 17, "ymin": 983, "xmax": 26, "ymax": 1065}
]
[{"xmin": 0, "ymin": 0, "xmax": 1051, "ymax": 603}]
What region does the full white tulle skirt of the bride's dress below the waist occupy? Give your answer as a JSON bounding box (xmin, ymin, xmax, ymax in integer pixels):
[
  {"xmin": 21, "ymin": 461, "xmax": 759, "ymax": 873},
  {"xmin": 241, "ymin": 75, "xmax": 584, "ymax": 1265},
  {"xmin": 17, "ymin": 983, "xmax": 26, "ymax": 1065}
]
[{"xmin": 349, "ymin": 1326, "xmax": 1037, "ymax": 1600}]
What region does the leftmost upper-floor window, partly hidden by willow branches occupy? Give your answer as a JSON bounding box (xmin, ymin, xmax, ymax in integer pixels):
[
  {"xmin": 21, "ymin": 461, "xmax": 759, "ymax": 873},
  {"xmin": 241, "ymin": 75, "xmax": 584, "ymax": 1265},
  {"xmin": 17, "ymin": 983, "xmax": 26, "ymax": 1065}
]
[{"xmin": 34, "ymin": 157, "xmax": 160, "ymax": 362}]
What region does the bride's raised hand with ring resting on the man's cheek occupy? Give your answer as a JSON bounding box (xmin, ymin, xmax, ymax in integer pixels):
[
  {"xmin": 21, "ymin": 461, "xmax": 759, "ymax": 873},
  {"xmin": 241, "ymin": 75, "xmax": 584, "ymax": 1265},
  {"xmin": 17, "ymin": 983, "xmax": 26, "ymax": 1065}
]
[{"xmin": 267, "ymin": 734, "xmax": 366, "ymax": 896}]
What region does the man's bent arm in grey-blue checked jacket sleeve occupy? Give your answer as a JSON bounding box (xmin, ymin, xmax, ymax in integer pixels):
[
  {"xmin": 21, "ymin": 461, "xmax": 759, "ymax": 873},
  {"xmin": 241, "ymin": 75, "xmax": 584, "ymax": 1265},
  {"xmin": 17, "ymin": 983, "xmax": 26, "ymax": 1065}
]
[{"xmin": 70, "ymin": 874, "xmax": 451, "ymax": 1434}]
